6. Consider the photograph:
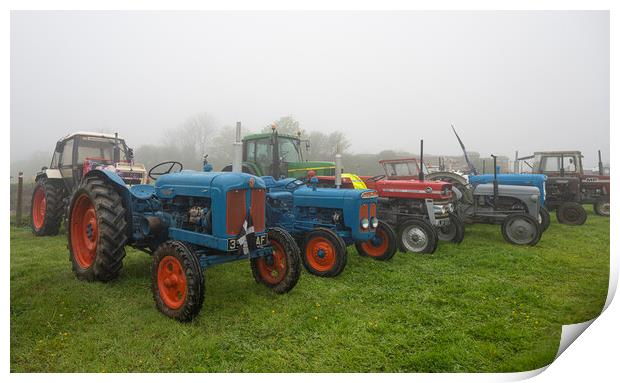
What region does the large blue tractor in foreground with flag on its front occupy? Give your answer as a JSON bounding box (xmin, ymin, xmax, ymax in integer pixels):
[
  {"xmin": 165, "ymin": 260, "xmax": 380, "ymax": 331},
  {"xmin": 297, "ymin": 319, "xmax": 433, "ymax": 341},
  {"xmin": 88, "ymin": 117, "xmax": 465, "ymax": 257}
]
[{"xmin": 67, "ymin": 161, "xmax": 301, "ymax": 321}]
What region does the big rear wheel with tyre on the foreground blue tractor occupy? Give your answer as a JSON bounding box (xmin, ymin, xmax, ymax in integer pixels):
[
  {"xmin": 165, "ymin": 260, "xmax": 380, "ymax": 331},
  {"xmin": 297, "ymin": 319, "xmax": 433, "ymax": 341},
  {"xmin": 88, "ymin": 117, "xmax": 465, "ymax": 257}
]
[{"xmin": 67, "ymin": 176, "xmax": 127, "ymax": 282}]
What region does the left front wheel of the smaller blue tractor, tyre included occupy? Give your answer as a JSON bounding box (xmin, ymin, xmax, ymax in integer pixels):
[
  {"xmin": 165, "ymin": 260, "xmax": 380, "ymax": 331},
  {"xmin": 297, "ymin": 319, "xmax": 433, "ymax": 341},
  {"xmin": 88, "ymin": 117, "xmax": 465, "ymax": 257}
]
[{"xmin": 301, "ymin": 227, "xmax": 347, "ymax": 277}]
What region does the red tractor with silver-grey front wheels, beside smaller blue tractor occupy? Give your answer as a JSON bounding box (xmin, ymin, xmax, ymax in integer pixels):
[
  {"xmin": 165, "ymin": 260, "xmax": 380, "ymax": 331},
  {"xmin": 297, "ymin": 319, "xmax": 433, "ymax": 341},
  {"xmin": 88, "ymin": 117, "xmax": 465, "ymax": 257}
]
[{"xmin": 318, "ymin": 142, "xmax": 465, "ymax": 253}]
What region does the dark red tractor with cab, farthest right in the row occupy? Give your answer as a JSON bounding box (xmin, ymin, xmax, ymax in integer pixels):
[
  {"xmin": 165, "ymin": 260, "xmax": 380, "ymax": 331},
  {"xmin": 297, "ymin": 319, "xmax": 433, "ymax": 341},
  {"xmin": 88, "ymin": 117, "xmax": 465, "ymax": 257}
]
[{"xmin": 519, "ymin": 151, "xmax": 610, "ymax": 225}]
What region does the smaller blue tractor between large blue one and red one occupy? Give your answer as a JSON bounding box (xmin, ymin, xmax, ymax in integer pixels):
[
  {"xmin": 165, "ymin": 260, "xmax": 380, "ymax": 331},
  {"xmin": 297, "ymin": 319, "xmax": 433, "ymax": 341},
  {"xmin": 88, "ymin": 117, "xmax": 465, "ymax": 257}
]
[{"xmin": 262, "ymin": 176, "xmax": 397, "ymax": 277}]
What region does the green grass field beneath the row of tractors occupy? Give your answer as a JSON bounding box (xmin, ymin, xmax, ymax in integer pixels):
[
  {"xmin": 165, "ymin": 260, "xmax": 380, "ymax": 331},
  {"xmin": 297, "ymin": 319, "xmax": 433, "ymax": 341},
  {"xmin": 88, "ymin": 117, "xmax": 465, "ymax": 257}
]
[{"xmin": 11, "ymin": 211, "xmax": 609, "ymax": 372}]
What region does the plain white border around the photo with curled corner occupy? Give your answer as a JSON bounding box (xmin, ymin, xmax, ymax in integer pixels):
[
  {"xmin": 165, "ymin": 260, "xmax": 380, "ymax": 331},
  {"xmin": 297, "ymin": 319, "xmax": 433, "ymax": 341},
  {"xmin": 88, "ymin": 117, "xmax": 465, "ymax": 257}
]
[{"xmin": 0, "ymin": 0, "xmax": 620, "ymax": 382}]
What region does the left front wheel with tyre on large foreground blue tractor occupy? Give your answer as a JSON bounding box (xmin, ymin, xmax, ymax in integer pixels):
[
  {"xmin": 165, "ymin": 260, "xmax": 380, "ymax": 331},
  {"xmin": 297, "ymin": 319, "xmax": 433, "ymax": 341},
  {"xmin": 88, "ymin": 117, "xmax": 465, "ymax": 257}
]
[{"xmin": 151, "ymin": 241, "xmax": 205, "ymax": 322}]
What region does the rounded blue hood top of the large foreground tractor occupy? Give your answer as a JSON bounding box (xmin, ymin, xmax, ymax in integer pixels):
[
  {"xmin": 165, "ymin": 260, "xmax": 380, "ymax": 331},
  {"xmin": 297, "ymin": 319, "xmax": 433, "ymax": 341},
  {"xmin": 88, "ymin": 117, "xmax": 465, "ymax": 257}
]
[{"xmin": 155, "ymin": 170, "xmax": 265, "ymax": 198}]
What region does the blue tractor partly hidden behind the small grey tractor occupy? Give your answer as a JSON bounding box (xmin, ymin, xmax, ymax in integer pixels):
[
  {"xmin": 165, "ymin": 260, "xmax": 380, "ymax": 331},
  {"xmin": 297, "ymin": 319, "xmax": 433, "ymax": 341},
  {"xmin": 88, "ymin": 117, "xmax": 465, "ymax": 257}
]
[{"xmin": 427, "ymin": 125, "xmax": 551, "ymax": 231}]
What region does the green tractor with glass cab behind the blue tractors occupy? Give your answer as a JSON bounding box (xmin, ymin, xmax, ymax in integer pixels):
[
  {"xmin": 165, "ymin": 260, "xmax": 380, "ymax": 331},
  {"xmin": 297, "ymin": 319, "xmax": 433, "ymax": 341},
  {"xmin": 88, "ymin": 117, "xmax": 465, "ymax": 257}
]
[{"xmin": 222, "ymin": 126, "xmax": 336, "ymax": 179}]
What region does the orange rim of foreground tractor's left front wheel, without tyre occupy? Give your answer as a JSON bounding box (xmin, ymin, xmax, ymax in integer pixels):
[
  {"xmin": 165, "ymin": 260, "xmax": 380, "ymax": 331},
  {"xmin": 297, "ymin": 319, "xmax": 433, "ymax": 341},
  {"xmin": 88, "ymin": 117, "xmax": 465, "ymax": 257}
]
[{"xmin": 157, "ymin": 255, "xmax": 187, "ymax": 310}]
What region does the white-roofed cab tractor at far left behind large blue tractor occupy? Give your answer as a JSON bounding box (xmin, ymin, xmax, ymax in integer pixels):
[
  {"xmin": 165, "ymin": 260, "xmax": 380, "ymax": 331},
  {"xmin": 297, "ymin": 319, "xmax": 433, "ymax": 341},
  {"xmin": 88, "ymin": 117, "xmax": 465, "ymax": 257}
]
[{"xmin": 30, "ymin": 132, "xmax": 147, "ymax": 236}]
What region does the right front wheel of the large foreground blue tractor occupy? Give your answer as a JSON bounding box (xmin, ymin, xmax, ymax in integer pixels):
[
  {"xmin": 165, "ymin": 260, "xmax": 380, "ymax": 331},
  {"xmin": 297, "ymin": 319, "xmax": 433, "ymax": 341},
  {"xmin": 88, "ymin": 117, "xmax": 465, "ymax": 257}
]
[{"xmin": 250, "ymin": 228, "xmax": 301, "ymax": 294}]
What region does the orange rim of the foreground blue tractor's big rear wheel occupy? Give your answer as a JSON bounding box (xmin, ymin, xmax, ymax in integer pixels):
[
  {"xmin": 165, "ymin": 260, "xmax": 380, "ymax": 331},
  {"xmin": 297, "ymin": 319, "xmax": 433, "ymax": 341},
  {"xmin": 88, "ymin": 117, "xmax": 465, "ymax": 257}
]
[{"xmin": 71, "ymin": 194, "xmax": 99, "ymax": 269}]
